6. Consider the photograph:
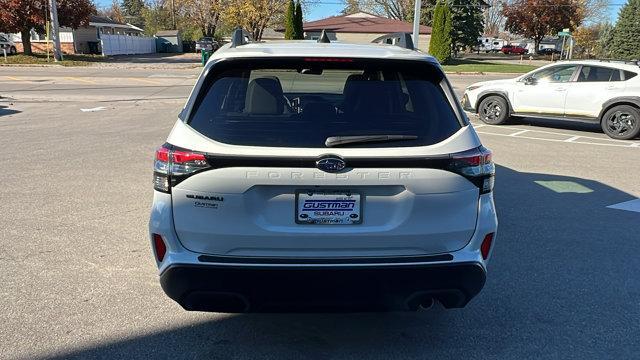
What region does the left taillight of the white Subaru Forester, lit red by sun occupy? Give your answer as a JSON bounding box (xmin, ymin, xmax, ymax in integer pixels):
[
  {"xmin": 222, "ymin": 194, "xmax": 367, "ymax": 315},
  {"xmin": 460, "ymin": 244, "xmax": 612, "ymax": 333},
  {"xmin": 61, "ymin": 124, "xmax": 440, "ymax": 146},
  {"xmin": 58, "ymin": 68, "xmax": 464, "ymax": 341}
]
[{"xmin": 153, "ymin": 145, "xmax": 210, "ymax": 193}]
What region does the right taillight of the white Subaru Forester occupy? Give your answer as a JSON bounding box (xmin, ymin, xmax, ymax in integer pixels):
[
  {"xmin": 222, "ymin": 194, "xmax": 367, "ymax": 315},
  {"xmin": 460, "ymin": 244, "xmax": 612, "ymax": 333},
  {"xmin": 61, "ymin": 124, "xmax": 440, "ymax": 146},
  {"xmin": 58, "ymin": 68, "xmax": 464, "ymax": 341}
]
[{"xmin": 449, "ymin": 146, "xmax": 496, "ymax": 194}]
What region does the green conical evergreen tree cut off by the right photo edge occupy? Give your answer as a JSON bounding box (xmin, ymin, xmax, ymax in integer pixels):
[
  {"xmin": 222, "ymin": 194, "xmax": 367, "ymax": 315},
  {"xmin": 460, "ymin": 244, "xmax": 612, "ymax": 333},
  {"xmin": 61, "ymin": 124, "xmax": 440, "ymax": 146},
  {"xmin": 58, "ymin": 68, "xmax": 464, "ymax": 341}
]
[{"xmin": 609, "ymin": 0, "xmax": 640, "ymax": 60}]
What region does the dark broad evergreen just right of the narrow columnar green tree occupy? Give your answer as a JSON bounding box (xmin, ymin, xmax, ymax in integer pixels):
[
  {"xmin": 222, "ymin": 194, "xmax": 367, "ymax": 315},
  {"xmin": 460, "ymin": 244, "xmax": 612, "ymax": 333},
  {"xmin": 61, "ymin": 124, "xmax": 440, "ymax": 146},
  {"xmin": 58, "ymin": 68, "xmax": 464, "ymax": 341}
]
[{"xmin": 450, "ymin": 0, "xmax": 484, "ymax": 55}]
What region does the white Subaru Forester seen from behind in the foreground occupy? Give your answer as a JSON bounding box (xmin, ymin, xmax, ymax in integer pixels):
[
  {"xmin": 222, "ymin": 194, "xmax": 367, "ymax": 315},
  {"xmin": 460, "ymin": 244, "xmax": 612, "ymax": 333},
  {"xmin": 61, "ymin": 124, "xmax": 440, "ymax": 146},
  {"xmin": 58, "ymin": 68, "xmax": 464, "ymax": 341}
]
[{"xmin": 149, "ymin": 32, "xmax": 497, "ymax": 312}]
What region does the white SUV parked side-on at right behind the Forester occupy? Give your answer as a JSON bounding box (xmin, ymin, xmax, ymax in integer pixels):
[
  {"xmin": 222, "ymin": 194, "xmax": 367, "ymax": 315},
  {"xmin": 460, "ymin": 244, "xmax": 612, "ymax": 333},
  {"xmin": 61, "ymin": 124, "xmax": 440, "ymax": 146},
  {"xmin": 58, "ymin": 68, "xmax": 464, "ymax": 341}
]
[{"xmin": 462, "ymin": 60, "xmax": 640, "ymax": 140}]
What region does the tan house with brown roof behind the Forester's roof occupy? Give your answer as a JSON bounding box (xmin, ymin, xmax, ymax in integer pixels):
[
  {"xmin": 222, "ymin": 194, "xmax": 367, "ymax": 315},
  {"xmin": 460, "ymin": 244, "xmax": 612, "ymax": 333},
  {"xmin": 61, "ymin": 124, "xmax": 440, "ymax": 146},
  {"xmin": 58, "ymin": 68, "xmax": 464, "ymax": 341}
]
[{"xmin": 303, "ymin": 12, "xmax": 431, "ymax": 51}]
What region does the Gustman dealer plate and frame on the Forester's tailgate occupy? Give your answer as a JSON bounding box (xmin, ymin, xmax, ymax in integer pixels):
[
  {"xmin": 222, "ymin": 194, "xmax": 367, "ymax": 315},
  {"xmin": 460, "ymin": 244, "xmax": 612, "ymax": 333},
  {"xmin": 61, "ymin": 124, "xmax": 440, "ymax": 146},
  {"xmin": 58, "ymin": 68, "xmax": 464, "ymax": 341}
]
[{"xmin": 294, "ymin": 189, "xmax": 363, "ymax": 225}]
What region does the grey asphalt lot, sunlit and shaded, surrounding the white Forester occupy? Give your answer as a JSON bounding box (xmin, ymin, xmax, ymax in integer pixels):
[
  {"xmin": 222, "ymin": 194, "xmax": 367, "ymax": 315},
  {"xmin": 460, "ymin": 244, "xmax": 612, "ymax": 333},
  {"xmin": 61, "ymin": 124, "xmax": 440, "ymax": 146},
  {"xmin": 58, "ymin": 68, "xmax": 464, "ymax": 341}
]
[{"xmin": 0, "ymin": 68, "xmax": 640, "ymax": 359}]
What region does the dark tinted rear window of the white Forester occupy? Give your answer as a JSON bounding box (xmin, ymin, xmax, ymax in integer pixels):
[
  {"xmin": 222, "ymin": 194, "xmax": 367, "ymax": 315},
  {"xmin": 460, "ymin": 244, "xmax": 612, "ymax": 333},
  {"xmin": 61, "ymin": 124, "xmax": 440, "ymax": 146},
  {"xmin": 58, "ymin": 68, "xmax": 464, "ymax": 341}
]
[{"xmin": 188, "ymin": 59, "xmax": 461, "ymax": 148}]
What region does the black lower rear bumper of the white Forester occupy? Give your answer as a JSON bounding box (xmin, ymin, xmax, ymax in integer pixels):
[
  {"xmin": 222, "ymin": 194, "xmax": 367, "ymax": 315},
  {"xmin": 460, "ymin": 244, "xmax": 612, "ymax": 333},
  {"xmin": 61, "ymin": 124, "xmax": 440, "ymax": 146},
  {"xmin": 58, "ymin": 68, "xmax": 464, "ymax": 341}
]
[{"xmin": 160, "ymin": 262, "xmax": 486, "ymax": 313}]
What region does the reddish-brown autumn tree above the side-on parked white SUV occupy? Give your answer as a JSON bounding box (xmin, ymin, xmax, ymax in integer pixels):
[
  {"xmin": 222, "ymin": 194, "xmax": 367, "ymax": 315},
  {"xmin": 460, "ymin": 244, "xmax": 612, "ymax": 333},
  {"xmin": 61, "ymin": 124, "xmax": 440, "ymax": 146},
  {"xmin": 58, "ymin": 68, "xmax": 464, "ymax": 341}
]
[{"xmin": 503, "ymin": 0, "xmax": 584, "ymax": 49}]
